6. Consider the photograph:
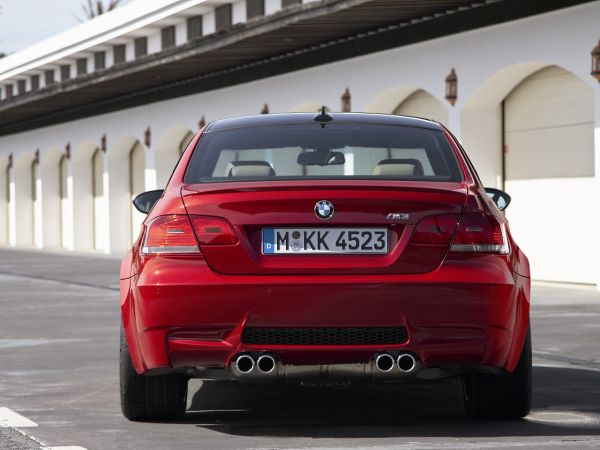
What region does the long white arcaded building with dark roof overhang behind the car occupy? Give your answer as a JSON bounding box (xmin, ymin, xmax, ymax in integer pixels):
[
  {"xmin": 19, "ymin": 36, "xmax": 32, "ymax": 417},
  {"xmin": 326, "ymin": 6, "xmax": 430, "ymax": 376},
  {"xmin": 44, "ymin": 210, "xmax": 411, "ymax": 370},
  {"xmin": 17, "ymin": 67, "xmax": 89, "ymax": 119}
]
[{"xmin": 0, "ymin": 0, "xmax": 600, "ymax": 285}]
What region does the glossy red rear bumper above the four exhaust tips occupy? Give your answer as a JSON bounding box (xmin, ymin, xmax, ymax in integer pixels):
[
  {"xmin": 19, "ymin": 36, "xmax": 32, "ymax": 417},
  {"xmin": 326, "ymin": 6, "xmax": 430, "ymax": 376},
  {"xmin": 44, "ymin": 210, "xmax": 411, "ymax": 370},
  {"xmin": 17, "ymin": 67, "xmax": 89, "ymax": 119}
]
[{"xmin": 122, "ymin": 256, "xmax": 530, "ymax": 373}]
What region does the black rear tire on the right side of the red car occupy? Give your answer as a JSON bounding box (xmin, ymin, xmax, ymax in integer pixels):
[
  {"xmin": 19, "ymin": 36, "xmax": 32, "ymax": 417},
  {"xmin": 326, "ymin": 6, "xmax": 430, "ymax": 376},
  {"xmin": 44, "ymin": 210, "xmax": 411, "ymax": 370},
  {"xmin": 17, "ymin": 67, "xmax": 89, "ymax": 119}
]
[{"xmin": 463, "ymin": 327, "xmax": 531, "ymax": 419}]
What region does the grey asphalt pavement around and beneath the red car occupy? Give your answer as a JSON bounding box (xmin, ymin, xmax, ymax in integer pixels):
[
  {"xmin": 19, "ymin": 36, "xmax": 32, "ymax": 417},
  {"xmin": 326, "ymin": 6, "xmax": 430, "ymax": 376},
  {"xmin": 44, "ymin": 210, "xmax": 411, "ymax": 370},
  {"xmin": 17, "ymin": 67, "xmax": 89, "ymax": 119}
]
[{"xmin": 0, "ymin": 250, "xmax": 600, "ymax": 450}]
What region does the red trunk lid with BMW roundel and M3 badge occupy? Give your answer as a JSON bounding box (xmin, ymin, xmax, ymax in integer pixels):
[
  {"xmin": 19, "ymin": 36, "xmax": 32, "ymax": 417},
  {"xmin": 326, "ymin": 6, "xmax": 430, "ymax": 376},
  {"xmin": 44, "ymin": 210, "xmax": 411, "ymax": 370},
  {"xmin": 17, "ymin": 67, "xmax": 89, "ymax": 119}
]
[{"xmin": 181, "ymin": 180, "xmax": 467, "ymax": 275}]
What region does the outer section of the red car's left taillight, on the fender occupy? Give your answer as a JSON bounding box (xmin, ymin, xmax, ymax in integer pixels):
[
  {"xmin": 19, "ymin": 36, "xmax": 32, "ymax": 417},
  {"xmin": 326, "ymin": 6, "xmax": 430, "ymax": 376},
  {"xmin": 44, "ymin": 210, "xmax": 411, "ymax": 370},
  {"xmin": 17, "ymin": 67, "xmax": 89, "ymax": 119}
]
[{"xmin": 142, "ymin": 214, "xmax": 200, "ymax": 255}]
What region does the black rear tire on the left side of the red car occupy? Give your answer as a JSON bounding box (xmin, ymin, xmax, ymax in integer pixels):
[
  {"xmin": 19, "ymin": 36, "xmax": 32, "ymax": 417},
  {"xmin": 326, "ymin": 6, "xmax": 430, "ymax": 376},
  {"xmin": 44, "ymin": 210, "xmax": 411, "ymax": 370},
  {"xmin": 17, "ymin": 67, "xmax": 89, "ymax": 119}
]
[{"xmin": 119, "ymin": 325, "xmax": 187, "ymax": 420}]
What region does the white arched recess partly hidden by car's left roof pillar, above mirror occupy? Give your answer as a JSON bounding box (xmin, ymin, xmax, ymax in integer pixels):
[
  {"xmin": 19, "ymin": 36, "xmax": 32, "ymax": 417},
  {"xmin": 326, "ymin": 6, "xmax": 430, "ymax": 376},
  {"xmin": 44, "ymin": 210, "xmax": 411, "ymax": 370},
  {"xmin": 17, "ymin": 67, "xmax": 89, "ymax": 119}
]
[{"xmin": 154, "ymin": 125, "xmax": 194, "ymax": 189}]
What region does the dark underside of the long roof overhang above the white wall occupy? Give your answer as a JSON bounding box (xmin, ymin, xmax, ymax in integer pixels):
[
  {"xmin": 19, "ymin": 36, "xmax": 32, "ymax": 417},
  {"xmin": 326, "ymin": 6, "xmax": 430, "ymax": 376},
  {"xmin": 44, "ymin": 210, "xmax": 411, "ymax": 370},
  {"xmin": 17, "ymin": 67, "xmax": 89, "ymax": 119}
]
[{"xmin": 0, "ymin": 0, "xmax": 586, "ymax": 135}]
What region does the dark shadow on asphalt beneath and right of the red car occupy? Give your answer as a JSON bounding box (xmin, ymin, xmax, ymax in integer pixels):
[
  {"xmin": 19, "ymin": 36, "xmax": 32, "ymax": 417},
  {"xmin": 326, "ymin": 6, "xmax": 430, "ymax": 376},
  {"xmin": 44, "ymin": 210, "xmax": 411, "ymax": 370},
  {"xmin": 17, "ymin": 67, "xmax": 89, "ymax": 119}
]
[{"xmin": 182, "ymin": 367, "xmax": 600, "ymax": 438}]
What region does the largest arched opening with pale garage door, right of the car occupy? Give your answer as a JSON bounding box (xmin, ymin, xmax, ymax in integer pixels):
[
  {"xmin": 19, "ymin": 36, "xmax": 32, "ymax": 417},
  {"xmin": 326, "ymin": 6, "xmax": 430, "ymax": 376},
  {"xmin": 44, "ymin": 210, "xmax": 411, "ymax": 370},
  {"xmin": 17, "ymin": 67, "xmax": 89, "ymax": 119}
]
[{"xmin": 502, "ymin": 66, "xmax": 597, "ymax": 283}]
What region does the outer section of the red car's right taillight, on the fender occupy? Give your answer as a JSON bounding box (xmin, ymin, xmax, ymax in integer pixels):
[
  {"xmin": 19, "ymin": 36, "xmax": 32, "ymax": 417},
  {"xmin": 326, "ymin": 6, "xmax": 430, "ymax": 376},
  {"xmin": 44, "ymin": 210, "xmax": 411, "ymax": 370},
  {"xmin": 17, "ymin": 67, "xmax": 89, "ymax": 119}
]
[{"xmin": 450, "ymin": 213, "xmax": 509, "ymax": 254}]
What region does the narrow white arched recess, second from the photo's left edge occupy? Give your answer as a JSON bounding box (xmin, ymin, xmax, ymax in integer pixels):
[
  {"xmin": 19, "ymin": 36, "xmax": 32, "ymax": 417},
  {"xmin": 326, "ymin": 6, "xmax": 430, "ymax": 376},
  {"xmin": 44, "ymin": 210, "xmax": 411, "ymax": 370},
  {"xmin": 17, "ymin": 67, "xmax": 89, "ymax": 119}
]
[{"xmin": 10, "ymin": 152, "xmax": 34, "ymax": 246}]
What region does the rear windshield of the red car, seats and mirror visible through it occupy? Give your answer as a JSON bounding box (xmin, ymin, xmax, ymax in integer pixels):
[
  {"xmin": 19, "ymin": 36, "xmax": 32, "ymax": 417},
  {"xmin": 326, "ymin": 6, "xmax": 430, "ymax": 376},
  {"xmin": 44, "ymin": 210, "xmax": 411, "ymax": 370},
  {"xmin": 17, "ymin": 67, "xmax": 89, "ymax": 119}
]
[{"xmin": 184, "ymin": 124, "xmax": 462, "ymax": 183}]
